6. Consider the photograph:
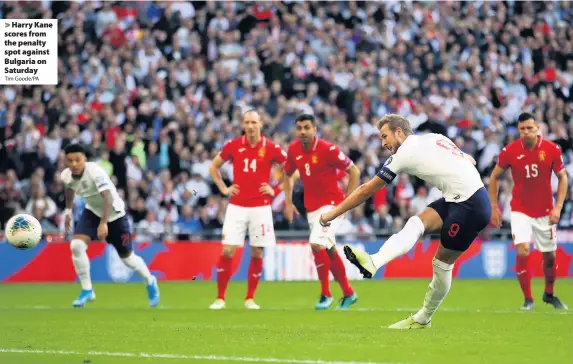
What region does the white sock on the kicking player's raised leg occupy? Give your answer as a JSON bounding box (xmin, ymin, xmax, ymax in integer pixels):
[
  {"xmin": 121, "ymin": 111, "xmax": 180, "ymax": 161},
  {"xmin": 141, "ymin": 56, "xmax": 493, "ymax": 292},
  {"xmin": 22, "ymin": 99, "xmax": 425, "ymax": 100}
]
[{"xmin": 371, "ymin": 216, "xmax": 424, "ymax": 268}]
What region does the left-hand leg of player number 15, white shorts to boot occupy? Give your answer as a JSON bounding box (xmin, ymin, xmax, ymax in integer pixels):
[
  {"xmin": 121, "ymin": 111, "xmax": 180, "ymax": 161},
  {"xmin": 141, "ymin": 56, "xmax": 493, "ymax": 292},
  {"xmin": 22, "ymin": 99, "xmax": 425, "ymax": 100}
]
[{"xmin": 510, "ymin": 212, "xmax": 533, "ymax": 310}]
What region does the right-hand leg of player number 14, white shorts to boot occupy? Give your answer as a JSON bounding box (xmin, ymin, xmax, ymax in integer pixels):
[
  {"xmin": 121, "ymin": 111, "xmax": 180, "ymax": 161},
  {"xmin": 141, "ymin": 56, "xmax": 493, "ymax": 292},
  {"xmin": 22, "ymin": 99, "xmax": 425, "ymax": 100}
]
[{"xmin": 245, "ymin": 206, "xmax": 276, "ymax": 310}]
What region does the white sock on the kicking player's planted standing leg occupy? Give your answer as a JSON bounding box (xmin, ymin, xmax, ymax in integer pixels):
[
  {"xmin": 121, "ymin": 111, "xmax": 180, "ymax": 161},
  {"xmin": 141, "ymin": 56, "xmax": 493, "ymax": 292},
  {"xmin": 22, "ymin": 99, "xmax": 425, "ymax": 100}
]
[{"xmin": 414, "ymin": 258, "xmax": 454, "ymax": 324}]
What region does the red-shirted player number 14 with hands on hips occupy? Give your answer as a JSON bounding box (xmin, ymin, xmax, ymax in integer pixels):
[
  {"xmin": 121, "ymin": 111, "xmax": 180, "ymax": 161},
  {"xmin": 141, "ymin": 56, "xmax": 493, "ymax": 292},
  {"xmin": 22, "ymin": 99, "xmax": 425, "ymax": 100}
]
[{"xmin": 209, "ymin": 110, "xmax": 286, "ymax": 310}]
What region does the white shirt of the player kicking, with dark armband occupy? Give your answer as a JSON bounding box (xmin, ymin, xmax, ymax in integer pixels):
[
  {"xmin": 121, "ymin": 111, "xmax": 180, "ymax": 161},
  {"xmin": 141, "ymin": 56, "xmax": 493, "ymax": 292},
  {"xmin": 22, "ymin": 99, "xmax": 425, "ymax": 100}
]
[{"xmin": 378, "ymin": 134, "xmax": 484, "ymax": 202}]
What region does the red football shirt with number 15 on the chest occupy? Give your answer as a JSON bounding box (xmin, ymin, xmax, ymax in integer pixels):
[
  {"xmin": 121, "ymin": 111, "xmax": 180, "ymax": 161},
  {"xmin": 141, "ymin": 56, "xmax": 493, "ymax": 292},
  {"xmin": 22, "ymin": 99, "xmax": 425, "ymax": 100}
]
[{"xmin": 497, "ymin": 136, "xmax": 565, "ymax": 218}]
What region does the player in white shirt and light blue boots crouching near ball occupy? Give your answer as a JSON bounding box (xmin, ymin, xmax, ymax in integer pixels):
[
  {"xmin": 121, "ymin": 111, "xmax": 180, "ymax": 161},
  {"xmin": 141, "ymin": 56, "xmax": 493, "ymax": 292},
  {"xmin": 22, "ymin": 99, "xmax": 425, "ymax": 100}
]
[{"xmin": 61, "ymin": 144, "xmax": 159, "ymax": 307}]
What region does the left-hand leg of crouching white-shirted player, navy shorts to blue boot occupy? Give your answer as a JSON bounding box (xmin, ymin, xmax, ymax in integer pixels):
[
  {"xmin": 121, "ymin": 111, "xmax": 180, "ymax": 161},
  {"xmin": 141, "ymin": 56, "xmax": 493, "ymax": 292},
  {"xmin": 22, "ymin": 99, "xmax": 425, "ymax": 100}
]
[{"xmin": 70, "ymin": 209, "xmax": 99, "ymax": 307}]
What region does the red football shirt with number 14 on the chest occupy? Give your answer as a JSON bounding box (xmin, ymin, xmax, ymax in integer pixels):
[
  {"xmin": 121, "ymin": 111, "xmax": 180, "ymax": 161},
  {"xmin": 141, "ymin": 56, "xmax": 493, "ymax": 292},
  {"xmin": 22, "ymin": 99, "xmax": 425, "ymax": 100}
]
[{"xmin": 220, "ymin": 136, "xmax": 286, "ymax": 207}]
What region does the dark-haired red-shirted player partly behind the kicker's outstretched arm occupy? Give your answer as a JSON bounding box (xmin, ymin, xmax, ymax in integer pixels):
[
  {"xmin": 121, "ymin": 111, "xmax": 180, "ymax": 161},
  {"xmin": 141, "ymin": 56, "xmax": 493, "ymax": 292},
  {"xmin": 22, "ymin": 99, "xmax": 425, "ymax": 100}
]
[{"xmin": 283, "ymin": 114, "xmax": 360, "ymax": 310}]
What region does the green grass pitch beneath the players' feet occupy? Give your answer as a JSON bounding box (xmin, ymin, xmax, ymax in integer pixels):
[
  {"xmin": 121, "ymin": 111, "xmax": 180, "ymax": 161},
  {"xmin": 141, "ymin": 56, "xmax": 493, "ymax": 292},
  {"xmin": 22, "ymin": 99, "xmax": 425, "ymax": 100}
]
[{"xmin": 0, "ymin": 279, "xmax": 573, "ymax": 364}]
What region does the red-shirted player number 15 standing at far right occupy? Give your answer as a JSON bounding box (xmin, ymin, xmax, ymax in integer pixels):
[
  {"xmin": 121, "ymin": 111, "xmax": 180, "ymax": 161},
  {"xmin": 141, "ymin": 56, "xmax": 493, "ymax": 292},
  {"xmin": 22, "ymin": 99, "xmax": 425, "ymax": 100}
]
[{"xmin": 489, "ymin": 113, "xmax": 567, "ymax": 310}]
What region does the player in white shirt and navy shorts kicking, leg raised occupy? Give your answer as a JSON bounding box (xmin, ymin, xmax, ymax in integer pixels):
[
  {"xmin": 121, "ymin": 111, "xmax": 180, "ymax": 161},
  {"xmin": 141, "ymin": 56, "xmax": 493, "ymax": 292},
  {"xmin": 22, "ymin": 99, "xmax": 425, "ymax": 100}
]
[{"xmin": 320, "ymin": 114, "xmax": 492, "ymax": 329}]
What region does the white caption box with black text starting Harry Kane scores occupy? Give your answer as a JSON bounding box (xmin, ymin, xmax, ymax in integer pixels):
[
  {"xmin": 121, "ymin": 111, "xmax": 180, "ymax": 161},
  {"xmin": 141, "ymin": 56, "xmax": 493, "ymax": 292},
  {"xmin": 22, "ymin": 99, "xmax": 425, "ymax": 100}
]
[{"xmin": 0, "ymin": 19, "xmax": 58, "ymax": 85}]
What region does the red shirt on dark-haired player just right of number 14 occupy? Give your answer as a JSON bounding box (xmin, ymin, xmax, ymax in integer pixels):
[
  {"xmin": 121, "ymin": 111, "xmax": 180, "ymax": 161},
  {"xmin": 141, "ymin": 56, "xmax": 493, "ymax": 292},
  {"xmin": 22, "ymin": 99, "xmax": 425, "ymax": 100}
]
[{"xmin": 285, "ymin": 138, "xmax": 352, "ymax": 212}]
